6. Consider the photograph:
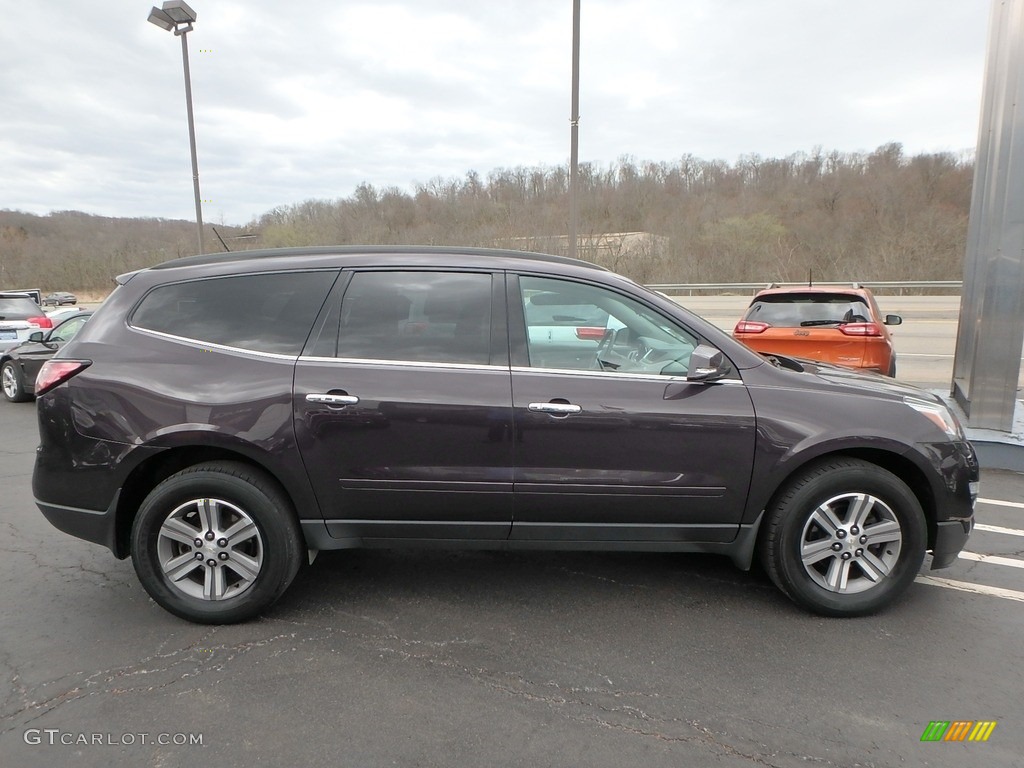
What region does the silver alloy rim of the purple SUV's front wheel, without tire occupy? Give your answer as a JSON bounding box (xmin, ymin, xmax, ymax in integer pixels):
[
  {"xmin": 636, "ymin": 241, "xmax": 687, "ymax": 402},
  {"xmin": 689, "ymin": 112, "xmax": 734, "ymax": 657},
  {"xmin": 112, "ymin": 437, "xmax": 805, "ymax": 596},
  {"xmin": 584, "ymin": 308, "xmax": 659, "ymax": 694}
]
[{"xmin": 800, "ymin": 494, "xmax": 903, "ymax": 594}]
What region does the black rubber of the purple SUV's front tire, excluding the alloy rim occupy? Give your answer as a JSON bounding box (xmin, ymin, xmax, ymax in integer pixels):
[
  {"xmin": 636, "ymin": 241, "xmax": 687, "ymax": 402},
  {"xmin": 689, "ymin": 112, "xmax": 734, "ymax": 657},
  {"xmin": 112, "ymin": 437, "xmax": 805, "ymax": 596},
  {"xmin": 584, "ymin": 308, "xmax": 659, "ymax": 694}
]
[{"xmin": 773, "ymin": 462, "xmax": 927, "ymax": 616}]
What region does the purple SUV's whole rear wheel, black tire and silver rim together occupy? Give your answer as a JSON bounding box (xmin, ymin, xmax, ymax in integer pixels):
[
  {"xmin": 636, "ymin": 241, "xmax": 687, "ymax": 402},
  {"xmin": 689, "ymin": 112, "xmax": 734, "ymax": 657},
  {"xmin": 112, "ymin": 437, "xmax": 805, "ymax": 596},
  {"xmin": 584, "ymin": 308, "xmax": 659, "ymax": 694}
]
[{"xmin": 131, "ymin": 462, "xmax": 304, "ymax": 624}]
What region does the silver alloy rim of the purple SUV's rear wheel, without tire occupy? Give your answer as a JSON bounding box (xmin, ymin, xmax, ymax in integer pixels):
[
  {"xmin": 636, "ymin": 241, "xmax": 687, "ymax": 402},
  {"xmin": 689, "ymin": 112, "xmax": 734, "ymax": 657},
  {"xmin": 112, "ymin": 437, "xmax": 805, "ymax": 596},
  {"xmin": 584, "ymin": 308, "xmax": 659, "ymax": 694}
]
[{"xmin": 157, "ymin": 499, "xmax": 263, "ymax": 600}]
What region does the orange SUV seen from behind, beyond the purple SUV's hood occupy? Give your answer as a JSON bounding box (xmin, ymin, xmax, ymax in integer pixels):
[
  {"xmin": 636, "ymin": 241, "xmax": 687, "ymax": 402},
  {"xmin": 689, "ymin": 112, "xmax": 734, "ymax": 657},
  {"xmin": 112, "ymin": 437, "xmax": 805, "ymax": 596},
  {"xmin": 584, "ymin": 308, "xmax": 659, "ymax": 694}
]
[{"xmin": 732, "ymin": 284, "xmax": 903, "ymax": 376}]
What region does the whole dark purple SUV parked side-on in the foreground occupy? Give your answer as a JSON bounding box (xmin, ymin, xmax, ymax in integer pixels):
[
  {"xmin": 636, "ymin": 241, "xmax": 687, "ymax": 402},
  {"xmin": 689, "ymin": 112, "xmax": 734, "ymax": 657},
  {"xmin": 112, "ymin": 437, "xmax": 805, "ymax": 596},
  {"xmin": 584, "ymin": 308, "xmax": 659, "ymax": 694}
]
[{"xmin": 33, "ymin": 248, "xmax": 978, "ymax": 623}]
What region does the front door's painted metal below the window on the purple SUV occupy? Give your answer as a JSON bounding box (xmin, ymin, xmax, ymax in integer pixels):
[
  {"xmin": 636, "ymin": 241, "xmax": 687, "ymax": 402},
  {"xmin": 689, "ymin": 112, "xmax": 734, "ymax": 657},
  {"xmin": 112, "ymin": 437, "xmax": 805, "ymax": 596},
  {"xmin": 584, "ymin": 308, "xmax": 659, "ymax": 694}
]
[{"xmin": 512, "ymin": 369, "xmax": 755, "ymax": 542}]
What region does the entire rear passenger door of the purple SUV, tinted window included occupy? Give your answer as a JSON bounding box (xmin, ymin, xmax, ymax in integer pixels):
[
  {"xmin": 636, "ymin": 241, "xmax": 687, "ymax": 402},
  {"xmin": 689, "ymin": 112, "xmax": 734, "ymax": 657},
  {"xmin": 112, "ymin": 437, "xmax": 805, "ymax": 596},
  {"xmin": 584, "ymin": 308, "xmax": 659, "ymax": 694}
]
[{"xmin": 294, "ymin": 271, "xmax": 512, "ymax": 541}]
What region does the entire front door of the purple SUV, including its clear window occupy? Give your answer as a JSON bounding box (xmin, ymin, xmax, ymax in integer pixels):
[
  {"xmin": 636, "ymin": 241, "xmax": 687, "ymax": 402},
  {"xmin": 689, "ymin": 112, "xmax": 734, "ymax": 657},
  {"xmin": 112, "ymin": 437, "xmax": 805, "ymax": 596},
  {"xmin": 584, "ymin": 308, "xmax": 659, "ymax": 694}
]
[{"xmin": 508, "ymin": 275, "xmax": 756, "ymax": 543}]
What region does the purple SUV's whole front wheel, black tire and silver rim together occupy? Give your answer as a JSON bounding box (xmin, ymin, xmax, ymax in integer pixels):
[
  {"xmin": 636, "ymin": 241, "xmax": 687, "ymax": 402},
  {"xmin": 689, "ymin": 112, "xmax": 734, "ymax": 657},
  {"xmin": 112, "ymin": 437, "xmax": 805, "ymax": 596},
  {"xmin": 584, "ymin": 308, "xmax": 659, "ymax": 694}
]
[{"xmin": 761, "ymin": 458, "xmax": 928, "ymax": 616}]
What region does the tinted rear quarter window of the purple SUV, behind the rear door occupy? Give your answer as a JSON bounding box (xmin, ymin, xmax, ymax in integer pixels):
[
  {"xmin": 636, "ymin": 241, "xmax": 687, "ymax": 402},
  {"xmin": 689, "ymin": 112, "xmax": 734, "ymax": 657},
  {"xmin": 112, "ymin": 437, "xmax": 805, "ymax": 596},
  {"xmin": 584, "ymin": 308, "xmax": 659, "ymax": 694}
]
[{"xmin": 130, "ymin": 271, "xmax": 337, "ymax": 355}]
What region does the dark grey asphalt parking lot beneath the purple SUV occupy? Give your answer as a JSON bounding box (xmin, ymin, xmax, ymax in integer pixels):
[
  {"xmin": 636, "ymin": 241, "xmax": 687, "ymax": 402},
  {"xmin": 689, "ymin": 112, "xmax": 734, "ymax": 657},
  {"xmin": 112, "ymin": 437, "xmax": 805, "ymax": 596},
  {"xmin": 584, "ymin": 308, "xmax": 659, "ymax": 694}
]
[{"xmin": 0, "ymin": 402, "xmax": 1024, "ymax": 768}]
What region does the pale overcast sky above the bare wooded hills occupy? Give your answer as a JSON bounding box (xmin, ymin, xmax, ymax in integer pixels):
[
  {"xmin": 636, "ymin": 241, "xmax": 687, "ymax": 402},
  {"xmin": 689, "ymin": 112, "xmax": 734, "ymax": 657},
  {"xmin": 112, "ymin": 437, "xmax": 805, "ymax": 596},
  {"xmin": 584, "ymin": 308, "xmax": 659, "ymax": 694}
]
[{"xmin": 0, "ymin": 0, "xmax": 991, "ymax": 224}]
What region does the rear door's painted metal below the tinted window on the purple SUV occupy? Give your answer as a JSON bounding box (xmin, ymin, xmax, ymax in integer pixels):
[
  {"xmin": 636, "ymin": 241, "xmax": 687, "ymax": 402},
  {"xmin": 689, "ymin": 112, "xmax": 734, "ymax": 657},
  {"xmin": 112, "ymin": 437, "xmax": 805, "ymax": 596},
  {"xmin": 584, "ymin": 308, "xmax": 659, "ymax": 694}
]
[{"xmin": 295, "ymin": 359, "xmax": 512, "ymax": 539}]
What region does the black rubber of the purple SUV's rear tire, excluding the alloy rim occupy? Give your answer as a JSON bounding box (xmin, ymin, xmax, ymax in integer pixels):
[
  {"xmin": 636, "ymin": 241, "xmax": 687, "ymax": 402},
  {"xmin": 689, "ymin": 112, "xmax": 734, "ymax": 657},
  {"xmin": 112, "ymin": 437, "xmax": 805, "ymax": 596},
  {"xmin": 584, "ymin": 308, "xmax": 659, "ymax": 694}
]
[{"xmin": 131, "ymin": 469, "xmax": 301, "ymax": 624}]
